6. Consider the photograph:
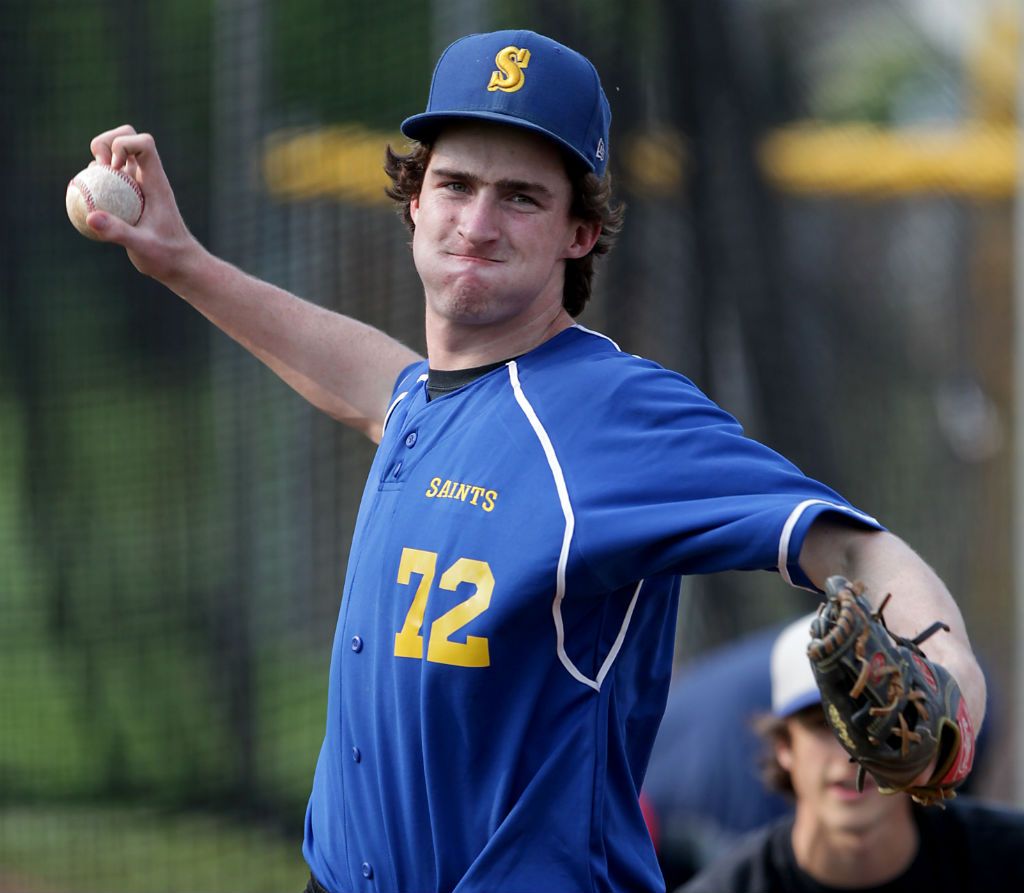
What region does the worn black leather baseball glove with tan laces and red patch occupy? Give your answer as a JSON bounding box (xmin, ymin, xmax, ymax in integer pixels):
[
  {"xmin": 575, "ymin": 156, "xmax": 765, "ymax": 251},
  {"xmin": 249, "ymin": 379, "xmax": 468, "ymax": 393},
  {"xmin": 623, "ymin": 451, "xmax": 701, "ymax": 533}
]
[{"xmin": 807, "ymin": 577, "xmax": 974, "ymax": 806}]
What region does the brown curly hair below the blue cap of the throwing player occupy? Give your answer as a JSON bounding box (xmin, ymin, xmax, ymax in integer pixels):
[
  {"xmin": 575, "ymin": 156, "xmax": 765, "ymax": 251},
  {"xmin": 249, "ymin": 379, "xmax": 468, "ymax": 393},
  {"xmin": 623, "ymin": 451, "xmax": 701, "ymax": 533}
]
[{"xmin": 384, "ymin": 142, "xmax": 625, "ymax": 317}]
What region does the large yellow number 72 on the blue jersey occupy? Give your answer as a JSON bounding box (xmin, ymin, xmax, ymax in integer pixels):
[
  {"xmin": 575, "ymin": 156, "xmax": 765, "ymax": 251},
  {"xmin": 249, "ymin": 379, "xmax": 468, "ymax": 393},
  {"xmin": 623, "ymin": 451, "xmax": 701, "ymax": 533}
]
[{"xmin": 394, "ymin": 549, "xmax": 495, "ymax": 667}]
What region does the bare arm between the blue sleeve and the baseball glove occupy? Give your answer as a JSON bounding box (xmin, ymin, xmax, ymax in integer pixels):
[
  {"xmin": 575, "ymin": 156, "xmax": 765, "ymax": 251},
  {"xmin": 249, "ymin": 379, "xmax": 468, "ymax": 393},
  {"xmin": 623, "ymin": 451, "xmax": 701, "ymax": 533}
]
[{"xmin": 800, "ymin": 521, "xmax": 986, "ymax": 732}]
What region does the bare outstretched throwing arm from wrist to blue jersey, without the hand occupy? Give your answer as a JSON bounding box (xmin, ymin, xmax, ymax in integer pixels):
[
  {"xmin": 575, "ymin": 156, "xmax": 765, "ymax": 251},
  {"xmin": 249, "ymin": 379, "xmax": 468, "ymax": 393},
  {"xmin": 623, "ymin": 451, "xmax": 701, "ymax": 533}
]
[{"xmin": 162, "ymin": 243, "xmax": 419, "ymax": 439}]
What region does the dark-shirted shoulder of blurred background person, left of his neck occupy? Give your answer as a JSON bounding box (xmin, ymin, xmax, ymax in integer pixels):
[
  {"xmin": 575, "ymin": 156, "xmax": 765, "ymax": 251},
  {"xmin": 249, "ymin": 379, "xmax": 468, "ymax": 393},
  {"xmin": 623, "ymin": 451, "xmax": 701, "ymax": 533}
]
[{"xmin": 677, "ymin": 816, "xmax": 793, "ymax": 893}]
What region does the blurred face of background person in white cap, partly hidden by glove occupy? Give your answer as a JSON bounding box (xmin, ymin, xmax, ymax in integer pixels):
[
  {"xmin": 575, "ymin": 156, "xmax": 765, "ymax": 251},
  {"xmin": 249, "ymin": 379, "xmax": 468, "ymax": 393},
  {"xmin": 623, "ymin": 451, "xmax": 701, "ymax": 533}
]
[{"xmin": 776, "ymin": 708, "xmax": 909, "ymax": 836}]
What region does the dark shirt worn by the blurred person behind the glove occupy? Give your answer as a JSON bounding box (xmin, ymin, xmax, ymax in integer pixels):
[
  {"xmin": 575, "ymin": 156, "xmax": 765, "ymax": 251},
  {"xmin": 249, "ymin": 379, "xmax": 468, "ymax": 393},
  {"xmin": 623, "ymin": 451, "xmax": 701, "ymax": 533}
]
[{"xmin": 678, "ymin": 798, "xmax": 1024, "ymax": 893}]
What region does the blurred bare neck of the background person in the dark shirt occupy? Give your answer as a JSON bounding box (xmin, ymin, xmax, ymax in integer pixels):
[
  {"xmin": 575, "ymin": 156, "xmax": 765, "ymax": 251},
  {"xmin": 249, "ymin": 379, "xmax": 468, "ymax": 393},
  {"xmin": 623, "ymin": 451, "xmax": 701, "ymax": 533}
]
[{"xmin": 793, "ymin": 804, "xmax": 919, "ymax": 887}]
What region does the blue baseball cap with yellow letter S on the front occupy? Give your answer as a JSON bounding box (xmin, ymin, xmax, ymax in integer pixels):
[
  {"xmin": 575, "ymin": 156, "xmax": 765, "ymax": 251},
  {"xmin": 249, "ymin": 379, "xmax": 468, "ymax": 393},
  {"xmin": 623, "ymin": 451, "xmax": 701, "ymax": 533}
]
[{"xmin": 401, "ymin": 31, "xmax": 611, "ymax": 176}]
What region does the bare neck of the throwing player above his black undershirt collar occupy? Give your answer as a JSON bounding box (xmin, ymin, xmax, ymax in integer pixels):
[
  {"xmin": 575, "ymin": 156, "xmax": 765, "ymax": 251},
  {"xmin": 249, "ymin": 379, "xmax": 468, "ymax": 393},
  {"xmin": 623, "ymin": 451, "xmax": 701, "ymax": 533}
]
[{"xmin": 426, "ymin": 305, "xmax": 573, "ymax": 370}]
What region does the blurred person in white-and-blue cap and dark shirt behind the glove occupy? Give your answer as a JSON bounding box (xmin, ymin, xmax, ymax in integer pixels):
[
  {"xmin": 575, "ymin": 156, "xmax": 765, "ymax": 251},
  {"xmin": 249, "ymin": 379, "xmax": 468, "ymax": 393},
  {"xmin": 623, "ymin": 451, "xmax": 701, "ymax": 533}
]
[{"xmin": 678, "ymin": 616, "xmax": 1024, "ymax": 893}]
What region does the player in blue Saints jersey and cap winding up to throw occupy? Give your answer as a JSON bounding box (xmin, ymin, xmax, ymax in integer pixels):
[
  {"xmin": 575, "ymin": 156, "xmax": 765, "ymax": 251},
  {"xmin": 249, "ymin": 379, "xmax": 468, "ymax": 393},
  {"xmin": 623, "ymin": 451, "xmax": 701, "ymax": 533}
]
[{"xmin": 81, "ymin": 31, "xmax": 985, "ymax": 893}]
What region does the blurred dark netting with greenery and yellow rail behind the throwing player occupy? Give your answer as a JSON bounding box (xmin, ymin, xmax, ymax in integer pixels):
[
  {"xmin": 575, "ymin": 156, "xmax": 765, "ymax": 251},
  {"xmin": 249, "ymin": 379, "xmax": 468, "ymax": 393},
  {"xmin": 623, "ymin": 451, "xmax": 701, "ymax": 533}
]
[{"xmin": 0, "ymin": 0, "xmax": 1017, "ymax": 893}]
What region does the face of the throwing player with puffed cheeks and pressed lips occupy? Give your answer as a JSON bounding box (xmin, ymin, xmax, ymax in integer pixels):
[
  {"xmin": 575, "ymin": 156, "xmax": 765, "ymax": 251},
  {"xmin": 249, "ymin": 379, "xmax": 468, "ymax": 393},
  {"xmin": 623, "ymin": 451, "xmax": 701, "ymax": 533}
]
[{"xmin": 411, "ymin": 122, "xmax": 598, "ymax": 337}]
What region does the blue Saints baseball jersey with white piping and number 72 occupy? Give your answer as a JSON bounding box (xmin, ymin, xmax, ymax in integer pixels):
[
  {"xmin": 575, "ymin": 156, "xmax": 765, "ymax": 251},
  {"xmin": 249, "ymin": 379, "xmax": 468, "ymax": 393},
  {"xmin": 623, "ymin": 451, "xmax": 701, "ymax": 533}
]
[{"xmin": 303, "ymin": 327, "xmax": 877, "ymax": 893}]
